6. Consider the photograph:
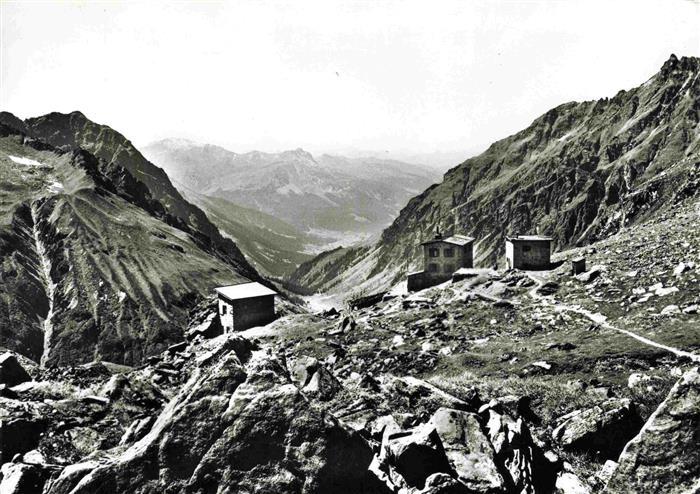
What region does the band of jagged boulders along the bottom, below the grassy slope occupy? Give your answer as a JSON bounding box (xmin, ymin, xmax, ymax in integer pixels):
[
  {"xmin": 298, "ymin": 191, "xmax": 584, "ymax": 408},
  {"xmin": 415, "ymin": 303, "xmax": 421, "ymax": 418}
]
[{"xmin": 0, "ymin": 302, "xmax": 700, "ymax": 494}]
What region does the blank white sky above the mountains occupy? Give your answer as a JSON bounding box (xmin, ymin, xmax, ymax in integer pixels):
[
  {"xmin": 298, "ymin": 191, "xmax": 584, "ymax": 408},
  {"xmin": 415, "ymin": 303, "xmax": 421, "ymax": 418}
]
[{"xmin": 0, "ymin": 0, "xmax": 700, "ymax": 157}]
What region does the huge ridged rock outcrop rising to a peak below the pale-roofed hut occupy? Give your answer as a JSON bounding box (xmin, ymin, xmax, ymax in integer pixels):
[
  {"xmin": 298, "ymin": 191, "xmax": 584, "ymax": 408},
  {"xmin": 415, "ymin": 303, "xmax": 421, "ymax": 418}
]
[{"xmin": 43, "ymin": 335, "xmax": 385, "ymax": 494}]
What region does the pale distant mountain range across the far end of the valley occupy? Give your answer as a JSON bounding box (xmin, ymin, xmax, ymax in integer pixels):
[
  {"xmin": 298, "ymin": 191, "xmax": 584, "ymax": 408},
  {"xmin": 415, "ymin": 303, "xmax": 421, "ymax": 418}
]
[{"xmin": 139, "ymin": 139, "xmax": 438, "ymax": 243}]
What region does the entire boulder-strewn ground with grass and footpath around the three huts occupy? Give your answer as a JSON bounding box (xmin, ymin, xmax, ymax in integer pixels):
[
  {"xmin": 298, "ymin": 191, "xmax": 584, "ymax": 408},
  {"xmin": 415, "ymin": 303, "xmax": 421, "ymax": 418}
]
[{"xmin": 0, "ymin": 197, "xmax": 700, "ymax": 494}]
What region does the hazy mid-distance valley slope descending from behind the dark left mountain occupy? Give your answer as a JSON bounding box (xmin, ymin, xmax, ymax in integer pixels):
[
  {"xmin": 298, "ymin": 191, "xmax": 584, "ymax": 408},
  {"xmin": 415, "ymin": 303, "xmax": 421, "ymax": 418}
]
[{"xmin": 180, "ymin": 186, "xmax": 320, "ymax": 278}]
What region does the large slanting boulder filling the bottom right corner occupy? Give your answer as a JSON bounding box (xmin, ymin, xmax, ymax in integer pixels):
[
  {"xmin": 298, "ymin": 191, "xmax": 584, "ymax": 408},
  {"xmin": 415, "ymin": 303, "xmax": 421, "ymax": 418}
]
[{"xmin": 607, "ymin": 368, "xmax": 700, "ymax": 494}]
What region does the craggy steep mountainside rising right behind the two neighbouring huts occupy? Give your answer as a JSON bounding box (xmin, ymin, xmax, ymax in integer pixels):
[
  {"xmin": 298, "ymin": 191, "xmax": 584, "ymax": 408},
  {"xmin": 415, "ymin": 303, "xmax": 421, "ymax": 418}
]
[{"xmin": 293, "ymin": 56, "xmax": 700, "ymax": 296}]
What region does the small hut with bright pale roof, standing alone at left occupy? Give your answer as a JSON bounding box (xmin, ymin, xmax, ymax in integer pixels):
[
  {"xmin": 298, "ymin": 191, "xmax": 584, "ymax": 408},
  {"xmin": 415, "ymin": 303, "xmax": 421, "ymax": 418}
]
[{"xmin": 215, "ymin": 282, "xmax": 277, "ymax": 333}]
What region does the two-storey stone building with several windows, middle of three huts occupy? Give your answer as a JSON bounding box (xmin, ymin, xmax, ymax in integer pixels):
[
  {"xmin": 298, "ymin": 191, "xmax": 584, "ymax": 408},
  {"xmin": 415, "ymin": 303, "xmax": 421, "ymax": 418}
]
[{"xmin": 408, "ymin": 232, "xmax": 474, "ymax": 291}]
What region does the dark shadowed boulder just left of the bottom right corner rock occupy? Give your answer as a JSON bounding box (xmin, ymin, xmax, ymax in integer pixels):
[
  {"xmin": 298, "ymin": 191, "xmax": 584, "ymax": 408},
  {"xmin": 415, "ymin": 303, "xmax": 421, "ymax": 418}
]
[{"xmin": 552, "ymin": 398, "xmax": 642, "ymax": 459}]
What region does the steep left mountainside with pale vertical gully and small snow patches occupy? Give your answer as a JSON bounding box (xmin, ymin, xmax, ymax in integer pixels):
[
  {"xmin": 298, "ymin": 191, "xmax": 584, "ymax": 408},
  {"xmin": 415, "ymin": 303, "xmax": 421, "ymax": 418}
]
[{"xmin": 0, "ymin": 114, "xmax": 258, "ymax": 365}]
